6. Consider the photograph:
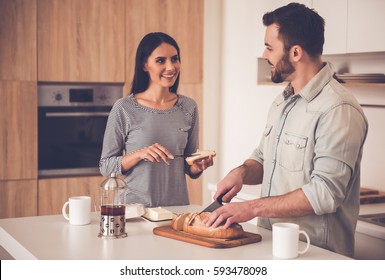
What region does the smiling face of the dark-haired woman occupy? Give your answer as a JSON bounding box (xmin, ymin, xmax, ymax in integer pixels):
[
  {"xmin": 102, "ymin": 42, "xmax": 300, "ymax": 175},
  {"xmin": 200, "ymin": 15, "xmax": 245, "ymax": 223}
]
[{"xmin": 144, "ymin": 43, "xmax": 180, "ymax": 88}]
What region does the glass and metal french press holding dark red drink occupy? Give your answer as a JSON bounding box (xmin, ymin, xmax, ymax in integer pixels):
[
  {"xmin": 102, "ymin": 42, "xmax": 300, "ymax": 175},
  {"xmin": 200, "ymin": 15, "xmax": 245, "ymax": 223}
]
[{"xmin": 98, "ymin": 173, "xmax": 128, "ymax": 238}]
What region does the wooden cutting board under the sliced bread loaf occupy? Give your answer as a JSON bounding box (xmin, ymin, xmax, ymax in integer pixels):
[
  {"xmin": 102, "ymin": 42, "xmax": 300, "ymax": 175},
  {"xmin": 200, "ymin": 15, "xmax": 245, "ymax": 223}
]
[{"xmin": 153, "ymin": 225, "xmax": 262, "ymax": 248}]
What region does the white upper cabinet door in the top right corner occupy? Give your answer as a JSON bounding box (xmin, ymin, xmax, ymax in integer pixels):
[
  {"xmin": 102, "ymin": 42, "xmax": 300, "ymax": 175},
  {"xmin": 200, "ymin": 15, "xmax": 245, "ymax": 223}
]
[{"xmin": 346, "ymin": 0, "xmax": 385, "ymax": 53}]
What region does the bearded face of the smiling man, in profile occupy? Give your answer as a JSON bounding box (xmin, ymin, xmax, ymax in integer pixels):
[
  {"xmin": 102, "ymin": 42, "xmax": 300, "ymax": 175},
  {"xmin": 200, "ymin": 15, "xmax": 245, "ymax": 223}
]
[{"xmin": 263, "ymin": 24, "xmax": 295, "ymax": 83}]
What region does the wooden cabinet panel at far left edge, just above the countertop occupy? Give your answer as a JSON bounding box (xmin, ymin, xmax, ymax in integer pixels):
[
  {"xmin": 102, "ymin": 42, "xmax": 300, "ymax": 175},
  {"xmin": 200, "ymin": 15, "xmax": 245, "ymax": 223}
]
[{"xmin": 0, "ymin": 180, "xmax": 37, "ymax": 219}]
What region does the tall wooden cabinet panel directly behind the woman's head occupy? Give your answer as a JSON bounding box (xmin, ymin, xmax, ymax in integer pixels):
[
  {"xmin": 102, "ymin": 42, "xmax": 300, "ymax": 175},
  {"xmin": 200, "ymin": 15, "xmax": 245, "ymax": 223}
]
[{"xmin": 126, "ymin": 0, "xmax": 203, "ymax": 84}]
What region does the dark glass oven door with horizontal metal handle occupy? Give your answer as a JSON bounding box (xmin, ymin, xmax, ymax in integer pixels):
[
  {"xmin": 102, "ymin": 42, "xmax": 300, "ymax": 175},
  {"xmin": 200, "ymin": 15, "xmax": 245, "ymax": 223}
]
[{"xmin": 38, "ymin": 107, "xmax": 111, "ymax": 178}]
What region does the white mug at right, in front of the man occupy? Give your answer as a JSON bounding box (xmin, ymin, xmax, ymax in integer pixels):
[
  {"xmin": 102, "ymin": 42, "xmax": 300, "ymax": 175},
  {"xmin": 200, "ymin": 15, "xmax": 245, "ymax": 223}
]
[{"xmin": 273, "ymin": 223, "xmax": 310, "ymax": 259}]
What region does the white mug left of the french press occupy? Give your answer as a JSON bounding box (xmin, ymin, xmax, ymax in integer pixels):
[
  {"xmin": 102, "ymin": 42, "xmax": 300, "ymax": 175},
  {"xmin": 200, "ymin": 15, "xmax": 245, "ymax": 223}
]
[{"xmin": 62, "ymin": 196, "xmax": 91, "ymax": 225}]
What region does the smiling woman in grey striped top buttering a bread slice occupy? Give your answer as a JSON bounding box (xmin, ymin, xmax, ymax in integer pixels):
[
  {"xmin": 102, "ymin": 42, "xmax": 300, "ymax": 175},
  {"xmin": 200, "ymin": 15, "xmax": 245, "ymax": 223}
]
[{"xmin": 99, "ymin": 32, "xmax": 213, "ymax": 207}]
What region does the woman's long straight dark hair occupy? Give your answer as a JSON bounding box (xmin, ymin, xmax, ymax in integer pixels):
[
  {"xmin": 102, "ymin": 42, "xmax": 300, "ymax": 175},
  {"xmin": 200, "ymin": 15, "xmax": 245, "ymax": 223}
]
[{"xmin": 131, "ymin": 32, "xmax": 180, "ymax": 94}]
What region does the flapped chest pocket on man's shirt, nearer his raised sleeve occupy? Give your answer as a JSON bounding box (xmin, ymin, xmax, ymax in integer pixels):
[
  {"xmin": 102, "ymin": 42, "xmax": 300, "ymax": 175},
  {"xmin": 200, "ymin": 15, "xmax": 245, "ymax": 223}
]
[{"xmin": 279, "ymin": 132, "xmax": 308, "ymax": 171}]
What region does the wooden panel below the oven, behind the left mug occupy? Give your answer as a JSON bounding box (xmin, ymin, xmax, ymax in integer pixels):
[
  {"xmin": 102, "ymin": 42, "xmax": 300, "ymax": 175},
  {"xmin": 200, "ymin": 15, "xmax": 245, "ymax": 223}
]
[{"xmin": 38, "ymin": 176, "xmax": 105, "ymax": 216}]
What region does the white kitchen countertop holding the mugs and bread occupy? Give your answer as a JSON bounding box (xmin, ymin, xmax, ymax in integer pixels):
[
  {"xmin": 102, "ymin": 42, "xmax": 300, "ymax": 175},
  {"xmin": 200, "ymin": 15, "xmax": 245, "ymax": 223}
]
[{"xmin": 0, "ymin": 205, "xmax": 348, "ymax": 260}]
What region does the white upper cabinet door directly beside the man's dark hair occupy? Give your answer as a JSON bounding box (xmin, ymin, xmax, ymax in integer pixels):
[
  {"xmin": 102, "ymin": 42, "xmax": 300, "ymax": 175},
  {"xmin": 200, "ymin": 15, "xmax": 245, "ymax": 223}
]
[{"xmin": 313, "ymin": 0, "xmax": 348, "ymax": 54}]
